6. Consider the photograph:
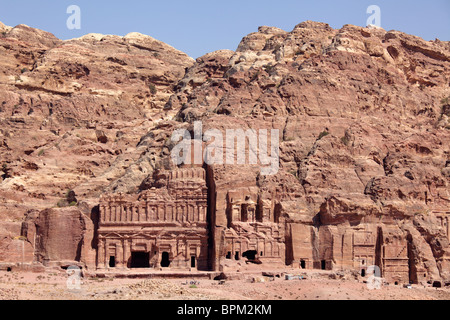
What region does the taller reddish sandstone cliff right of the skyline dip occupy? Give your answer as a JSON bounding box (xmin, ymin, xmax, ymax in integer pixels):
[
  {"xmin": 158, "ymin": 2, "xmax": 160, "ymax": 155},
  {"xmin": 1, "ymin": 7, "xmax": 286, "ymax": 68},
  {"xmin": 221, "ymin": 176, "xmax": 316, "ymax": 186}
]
[{"xmin": 103, "ymin": 22, "xmax": 450, "ymax": 282}]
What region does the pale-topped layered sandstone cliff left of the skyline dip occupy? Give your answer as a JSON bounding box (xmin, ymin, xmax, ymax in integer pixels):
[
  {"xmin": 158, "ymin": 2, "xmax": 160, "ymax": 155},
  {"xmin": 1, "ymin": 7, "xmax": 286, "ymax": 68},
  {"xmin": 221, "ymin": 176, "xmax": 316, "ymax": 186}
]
[{"xmin": 0, "ymin": 25, "xmax": 194, "ymax": 215}]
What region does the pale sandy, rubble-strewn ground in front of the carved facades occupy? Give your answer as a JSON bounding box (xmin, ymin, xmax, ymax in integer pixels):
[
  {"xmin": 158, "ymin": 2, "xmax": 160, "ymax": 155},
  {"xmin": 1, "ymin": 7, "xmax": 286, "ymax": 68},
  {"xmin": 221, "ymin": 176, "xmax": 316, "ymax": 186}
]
[{"xmin": 0, "ymin": 272, "xmax": 449, "ymax": 300}]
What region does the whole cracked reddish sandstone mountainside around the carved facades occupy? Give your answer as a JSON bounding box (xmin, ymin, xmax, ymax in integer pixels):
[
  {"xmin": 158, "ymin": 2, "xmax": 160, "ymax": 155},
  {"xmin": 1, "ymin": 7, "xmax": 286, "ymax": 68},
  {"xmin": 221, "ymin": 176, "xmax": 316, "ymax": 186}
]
[{"xmin": 0, "ymin": 21, "xmax": 450, "ymax": 282}]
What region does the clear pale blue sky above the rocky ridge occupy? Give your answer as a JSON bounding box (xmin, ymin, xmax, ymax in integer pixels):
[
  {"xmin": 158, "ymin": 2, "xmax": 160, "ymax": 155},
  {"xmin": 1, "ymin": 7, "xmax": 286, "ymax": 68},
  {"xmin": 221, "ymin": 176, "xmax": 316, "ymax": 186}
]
[{"xmin": 0, "ymin": 0, "xmax": 450, "ymax": 58}]
